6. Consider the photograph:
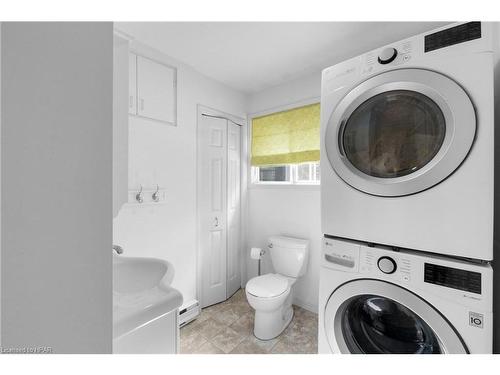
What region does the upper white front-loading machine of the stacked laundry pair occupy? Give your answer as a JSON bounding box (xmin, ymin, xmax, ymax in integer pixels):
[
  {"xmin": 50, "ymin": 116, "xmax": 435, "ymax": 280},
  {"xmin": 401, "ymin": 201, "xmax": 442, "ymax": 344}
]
[{"xmin": 321, "ymin": 22, "xmax": 496, "ymax": 260}]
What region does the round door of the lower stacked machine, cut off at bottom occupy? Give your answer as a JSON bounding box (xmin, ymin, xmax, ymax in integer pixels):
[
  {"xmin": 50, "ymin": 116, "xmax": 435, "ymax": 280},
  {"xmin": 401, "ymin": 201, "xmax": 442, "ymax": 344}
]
[{"xmin": 324, "ymin": 279, "xmax": 468, "ymax": 354}]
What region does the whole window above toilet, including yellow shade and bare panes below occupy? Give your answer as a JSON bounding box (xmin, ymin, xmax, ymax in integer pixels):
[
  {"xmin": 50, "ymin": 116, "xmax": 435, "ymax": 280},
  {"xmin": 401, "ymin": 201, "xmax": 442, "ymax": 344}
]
[{"xmin": 251, "ymin": 103, "xmax": 320, "ymax": 185}]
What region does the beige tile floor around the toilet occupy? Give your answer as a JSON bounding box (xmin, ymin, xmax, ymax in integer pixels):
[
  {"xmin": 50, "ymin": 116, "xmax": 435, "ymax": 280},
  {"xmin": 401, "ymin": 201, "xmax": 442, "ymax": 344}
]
[{"xmin": 180, "ymin": 289, "xmax": 318, "ymax": 354}]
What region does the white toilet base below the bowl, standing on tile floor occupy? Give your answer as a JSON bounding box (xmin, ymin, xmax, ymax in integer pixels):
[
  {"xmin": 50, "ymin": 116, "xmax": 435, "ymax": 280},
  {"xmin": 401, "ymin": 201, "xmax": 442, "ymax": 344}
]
[{"xmin": 253, "ymin": 298, "xmax": 293, "ymax": 340}]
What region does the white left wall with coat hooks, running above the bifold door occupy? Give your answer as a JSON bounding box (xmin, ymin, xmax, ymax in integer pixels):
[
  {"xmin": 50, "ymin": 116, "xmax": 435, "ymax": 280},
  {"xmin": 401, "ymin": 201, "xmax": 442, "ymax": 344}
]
[{"xmin": 113, "ymin": 42, "xmax": 247, "ymax": 301}]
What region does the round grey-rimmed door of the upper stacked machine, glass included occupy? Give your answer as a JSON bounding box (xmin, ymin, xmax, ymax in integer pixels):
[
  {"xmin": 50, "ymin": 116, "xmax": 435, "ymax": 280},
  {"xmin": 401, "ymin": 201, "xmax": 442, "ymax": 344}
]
[{"xmin": 324, "ymin": 69, "xmax": 476, "ymax": 197}]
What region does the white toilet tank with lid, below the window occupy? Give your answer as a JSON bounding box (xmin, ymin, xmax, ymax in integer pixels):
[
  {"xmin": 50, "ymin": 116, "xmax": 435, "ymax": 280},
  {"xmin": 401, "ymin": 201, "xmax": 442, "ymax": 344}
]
[{"xmin": 268, "ymin": 236, "xmax": 309, "ymax": 278}]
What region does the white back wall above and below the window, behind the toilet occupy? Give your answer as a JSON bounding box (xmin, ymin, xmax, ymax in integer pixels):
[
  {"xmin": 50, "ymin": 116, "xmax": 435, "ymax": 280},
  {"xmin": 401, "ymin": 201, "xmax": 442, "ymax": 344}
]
[{"xmin": 246, "ymin": 72, "xmax": 322, "ymax": 311}]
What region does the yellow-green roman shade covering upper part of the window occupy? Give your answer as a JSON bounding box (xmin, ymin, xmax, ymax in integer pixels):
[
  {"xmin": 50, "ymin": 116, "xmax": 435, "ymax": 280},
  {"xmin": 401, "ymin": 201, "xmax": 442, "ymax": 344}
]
[{"xmin": 251, "ymin": 103, "xmax": 320, "ymax": 166}]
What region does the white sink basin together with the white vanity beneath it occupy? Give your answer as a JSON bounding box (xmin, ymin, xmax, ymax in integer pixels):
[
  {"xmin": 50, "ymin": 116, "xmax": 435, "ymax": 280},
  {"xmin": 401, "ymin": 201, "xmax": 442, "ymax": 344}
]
[{"xmin": 113, "ymin": 254, "xmax": 182, "ymax": 354}]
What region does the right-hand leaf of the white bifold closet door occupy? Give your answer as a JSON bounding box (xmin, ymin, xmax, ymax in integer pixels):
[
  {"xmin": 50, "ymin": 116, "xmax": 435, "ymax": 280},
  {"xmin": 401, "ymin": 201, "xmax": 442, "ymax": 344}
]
[{"xmin": 227, "ymin": 121, "xmax": 241, "ymax": 297}]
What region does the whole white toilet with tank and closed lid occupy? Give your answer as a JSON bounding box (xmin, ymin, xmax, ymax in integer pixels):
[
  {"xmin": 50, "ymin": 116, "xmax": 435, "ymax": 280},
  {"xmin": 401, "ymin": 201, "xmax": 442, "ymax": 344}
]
[{"xmin": 245, "ymin": 236, "xmax": 309, "ymax": 340}]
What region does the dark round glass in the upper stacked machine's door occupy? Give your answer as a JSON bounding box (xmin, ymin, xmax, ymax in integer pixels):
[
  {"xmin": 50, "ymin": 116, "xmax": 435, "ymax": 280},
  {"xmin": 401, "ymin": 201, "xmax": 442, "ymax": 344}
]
[{"xmin": 340, "ymin": 90, "xmax": 446, "ymax": 178}]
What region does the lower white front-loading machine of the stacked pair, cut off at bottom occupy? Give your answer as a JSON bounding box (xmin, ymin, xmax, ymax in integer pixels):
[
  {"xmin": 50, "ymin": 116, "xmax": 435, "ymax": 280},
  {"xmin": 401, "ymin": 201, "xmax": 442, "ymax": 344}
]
[{"xmin": 318, "ymin": 238, "xmax": 493, "ymax": 354}]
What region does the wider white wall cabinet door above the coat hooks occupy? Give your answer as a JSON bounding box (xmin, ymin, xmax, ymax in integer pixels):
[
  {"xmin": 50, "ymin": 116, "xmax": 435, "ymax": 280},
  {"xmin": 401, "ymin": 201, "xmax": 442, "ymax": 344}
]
[{"xmin": 137, "ymin": 56, "xmax": 175, "ymax": 124}]
